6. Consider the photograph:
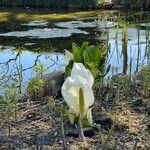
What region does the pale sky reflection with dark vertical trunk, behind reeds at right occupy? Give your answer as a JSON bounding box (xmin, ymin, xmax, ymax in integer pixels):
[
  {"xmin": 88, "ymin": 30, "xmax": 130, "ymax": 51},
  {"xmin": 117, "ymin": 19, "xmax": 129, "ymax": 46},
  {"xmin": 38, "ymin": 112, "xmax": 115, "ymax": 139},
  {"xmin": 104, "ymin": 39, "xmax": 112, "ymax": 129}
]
[{"xmin": 108, "ymin": 28, "xmax": 150, "ymax": 74}]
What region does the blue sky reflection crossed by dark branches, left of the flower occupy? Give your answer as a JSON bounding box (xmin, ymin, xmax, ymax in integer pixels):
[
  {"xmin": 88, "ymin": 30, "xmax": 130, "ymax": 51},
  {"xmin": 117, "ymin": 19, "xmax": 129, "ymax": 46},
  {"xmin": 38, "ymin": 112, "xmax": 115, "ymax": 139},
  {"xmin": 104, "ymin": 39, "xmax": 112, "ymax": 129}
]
[{"xmin": 0, "ymin": 46, "xmax": 65, "ymax": 94}]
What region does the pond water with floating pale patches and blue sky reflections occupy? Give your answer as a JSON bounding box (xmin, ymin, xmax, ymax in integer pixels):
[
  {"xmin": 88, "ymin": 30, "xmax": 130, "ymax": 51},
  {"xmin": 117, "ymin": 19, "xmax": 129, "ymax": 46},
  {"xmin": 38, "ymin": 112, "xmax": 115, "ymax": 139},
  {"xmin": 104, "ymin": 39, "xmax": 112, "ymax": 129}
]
[{"xmin": 0, "ymin": 10, "xmax": 150, "ymax": 94}]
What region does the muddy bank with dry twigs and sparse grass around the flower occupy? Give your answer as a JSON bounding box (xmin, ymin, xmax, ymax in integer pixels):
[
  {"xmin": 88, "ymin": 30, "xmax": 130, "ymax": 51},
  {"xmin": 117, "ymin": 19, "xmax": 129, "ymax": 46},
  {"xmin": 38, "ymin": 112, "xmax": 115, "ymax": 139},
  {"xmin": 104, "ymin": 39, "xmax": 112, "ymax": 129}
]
[{"xmin": 0, "ymin": 67, "xmax": 150, "ymax": 150}]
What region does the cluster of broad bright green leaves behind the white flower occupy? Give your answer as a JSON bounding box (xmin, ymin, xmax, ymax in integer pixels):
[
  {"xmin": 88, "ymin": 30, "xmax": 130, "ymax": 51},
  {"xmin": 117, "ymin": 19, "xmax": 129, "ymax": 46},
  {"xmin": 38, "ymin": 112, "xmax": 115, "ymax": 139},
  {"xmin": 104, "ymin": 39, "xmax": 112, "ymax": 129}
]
[{"xmin": 66, "ymin": 42, "xmax": 110, "ymax": 80}]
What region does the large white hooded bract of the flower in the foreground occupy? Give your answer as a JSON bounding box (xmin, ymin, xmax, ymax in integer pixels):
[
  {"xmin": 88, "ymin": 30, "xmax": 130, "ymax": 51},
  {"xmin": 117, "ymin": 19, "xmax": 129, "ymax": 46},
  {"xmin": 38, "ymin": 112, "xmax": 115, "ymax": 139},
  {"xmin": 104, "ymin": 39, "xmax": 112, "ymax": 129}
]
[{"xmin": 61, "ymin": 63, "xmax": 94, "ymax": 124}]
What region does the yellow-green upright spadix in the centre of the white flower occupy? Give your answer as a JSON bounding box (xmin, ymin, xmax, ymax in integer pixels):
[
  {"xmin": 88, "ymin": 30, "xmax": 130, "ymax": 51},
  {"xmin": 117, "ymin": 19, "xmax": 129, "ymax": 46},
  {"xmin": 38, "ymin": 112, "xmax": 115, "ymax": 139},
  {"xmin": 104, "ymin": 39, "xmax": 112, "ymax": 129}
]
[{"xmin": 79, "ymin": 87, "xmax": 85, "ymax": 115}]
